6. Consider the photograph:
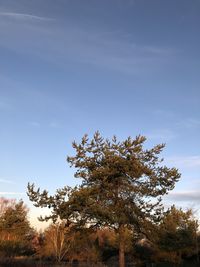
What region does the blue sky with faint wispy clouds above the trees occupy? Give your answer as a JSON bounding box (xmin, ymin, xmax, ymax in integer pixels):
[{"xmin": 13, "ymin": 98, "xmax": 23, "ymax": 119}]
[{"xmin": 0, "ymin": 0, "xmax": 200, "ymax": 229}]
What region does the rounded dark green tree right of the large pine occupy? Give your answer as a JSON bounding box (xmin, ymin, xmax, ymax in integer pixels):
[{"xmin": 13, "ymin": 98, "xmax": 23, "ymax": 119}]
[{"xmin": 157, "ymin": 206, "xmax": 198, "ymax": 263}]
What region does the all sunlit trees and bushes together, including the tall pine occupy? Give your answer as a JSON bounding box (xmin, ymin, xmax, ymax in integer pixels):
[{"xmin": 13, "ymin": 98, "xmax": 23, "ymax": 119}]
[{"xmin": 0, "ymin": 132, "xmax": 200, "ymax": 267}]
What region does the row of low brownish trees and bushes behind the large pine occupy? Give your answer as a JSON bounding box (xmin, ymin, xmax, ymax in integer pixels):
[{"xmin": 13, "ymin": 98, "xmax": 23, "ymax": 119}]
[{"xmin": 0, "ymin": 198, "xmax": 200, "ymax": 266}]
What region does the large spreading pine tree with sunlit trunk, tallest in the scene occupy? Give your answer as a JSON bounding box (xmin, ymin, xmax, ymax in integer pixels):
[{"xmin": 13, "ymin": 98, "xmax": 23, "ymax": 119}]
[{"xmin": 28, "ymin": 132, "xmax": 180, "ymax": 267}]
